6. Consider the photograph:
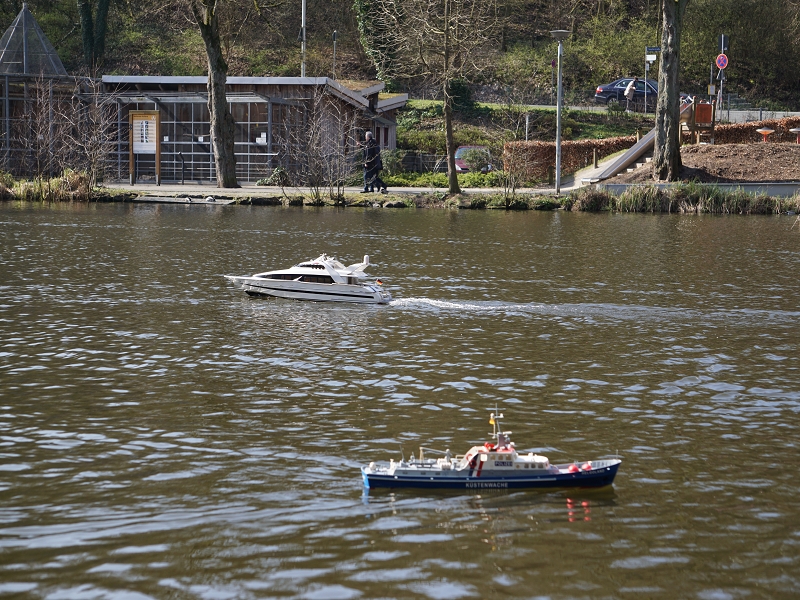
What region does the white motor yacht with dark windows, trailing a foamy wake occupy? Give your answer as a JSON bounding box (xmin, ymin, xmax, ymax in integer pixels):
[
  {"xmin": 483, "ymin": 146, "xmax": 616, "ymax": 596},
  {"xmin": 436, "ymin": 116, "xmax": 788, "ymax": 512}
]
[{"xmin": 225, "ymin": 254, "xmax": 392, "ymax": 304}]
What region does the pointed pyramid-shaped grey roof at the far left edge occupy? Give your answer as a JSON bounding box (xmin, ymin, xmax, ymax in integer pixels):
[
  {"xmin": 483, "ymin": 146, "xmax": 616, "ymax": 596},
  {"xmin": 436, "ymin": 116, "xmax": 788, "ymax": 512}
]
[{"xmin": 0, "ymin": 3, "xmax": 67, "ymax": 75}]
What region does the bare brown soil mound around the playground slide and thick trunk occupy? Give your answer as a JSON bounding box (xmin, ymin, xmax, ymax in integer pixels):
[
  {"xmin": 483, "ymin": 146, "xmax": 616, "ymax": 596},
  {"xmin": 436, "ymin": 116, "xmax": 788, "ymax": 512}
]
[{"xmin": 608, "ymin": 143, "xmax": 800, "ymax": 183}]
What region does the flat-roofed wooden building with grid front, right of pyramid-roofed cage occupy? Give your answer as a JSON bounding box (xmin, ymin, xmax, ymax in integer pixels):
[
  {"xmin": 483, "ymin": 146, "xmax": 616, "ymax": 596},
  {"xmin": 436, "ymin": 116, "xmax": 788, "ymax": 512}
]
[{"xmin": 102, "ymin": 76, "xmax": 408, "ymax": 184}]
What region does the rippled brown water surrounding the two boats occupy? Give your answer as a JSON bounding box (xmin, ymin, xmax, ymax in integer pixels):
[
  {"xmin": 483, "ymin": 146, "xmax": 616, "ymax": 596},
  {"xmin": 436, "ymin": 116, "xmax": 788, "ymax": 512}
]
[{"xmin": 0, "ymin": 203, "xmax": 800, "ymax": 600}]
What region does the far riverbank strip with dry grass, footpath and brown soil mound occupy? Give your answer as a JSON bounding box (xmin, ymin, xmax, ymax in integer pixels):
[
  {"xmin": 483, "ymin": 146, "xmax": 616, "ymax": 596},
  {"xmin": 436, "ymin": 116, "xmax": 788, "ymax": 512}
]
[{"xmin": 0, "ymin": 143, "xmax": 800, "ymax": 214}]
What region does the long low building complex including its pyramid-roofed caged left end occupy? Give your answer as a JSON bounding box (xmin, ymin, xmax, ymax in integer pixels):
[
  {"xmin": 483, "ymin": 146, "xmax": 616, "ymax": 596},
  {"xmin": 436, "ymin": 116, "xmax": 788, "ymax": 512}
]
[{"xmin": 0, "ymin": 4, "xmax": 408, "ymax": 185}]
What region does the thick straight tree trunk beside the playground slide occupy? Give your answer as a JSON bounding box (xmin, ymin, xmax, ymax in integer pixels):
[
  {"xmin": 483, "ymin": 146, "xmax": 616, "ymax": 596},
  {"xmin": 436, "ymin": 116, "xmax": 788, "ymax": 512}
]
[{"xmin": 653, "ymin": 0, "xmax": 689, "ymax": 181}]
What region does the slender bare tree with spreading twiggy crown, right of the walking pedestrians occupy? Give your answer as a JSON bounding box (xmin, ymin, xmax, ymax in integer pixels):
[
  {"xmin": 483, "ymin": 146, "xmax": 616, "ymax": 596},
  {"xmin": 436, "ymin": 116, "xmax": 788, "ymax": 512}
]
[{"xmin": 360, "ymin": 0, "xmax": 499, "ymax": 194}]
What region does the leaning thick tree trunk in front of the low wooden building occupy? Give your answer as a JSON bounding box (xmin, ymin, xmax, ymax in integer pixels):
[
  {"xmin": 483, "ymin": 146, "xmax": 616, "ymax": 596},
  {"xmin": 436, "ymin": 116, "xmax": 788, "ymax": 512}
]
[{"xmin": 192, "ymin": 0, "xmax": 239, "ymax": 188}]
